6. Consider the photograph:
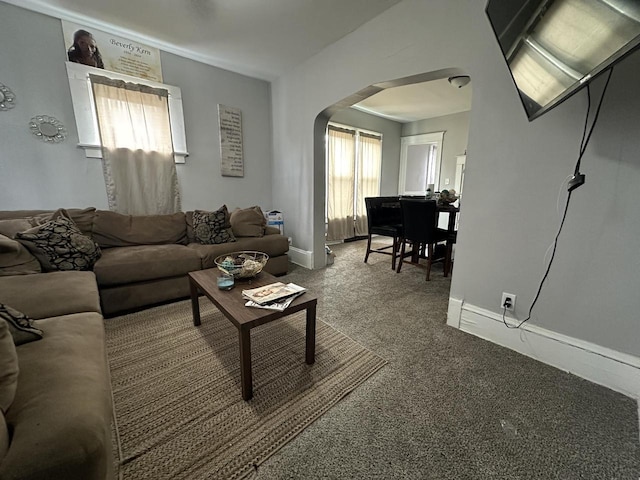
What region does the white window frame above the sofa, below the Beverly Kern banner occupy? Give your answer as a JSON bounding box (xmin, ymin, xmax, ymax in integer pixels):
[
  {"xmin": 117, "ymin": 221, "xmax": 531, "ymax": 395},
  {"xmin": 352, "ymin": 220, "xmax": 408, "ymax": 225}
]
[{"xmin": 66, "ymin": 62, "xmax": 189, "ymax": 163}]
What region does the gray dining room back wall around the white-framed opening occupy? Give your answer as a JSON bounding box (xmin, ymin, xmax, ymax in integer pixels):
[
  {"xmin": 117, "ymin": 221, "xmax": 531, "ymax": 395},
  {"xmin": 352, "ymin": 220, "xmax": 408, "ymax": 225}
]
[{"xmin": 402, "ymin": 111, "xmax": 471, "ymax": 190}]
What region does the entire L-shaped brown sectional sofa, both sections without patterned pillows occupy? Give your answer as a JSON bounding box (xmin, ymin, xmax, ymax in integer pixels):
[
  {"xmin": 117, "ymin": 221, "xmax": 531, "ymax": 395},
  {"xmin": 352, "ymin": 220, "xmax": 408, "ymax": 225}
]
[{"xmin": 0, "ymin": 208, "xmax": 289, "ymax": 480}]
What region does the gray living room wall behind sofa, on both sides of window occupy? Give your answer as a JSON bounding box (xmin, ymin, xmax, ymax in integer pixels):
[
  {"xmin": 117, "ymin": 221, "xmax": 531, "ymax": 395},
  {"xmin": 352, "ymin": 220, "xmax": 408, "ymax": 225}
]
[{"xmin": 0, "ymin": 2, "xmax": 272, "ymax": 210}]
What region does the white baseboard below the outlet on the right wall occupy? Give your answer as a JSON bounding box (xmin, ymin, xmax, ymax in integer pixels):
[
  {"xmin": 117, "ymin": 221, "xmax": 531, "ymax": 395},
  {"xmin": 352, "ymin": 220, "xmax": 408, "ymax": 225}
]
[{"xmin": 447, "ymin": 298, "xmax": 640, "ymax": 400}]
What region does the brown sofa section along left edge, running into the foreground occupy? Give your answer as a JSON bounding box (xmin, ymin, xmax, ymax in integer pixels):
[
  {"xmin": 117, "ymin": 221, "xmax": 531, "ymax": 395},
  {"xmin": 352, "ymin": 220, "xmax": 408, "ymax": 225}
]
[{"xmin": 0, "ymin": 272, "xmax": 113, "ymax": 480}]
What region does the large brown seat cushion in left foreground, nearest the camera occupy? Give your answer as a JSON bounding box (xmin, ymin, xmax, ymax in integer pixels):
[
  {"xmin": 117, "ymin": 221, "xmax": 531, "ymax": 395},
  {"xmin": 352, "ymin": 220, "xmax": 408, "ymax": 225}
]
[{"xmin": 0, "ymin": 313, "xmax": 113, "ymax": 480}]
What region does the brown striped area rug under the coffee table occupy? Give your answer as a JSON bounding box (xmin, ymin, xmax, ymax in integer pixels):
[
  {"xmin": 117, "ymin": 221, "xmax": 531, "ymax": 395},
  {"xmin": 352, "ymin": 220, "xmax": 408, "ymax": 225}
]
[{"xmin": 105, "ymin": 298, "xmax": 386, "ymax": 480}]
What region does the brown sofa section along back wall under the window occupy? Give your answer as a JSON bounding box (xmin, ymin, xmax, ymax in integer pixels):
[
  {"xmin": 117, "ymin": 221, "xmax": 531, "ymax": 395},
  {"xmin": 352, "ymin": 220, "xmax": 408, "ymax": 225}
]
[{"xmin": 0, "ymin": 208, "xmax": 289, "ymax": 316}]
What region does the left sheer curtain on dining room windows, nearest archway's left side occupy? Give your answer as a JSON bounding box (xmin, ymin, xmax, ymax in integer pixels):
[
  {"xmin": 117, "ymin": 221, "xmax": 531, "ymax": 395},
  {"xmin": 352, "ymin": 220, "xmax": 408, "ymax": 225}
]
[{"xmin": 327, "ymin": 127, "xmax": 355, "ymax": 240}]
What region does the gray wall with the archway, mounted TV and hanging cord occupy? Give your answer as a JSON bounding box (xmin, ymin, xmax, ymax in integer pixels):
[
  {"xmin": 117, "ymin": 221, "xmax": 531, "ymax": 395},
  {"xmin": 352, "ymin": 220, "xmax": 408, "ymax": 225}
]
[{"xmin": 272, "ymin": 0, "xmax": 640, "ymax": 356}]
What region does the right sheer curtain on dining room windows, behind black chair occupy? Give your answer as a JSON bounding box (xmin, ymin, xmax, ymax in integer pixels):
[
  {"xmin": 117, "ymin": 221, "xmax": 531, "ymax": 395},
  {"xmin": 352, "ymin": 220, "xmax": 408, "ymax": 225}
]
[{"xmin": 356, "ymin": 133, "xmax": 382, "ymax": 235}]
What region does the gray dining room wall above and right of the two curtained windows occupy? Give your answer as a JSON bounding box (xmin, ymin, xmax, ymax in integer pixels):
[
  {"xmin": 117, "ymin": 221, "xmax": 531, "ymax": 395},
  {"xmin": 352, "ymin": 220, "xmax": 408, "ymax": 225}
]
[{"xmin": 331, "ymin": 108, "xmax": 402, "ymax": 195}]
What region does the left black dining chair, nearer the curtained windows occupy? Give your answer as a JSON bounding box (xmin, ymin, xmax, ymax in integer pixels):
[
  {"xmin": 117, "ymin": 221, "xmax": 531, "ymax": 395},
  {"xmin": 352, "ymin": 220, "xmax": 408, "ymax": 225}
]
[{"xmin": 364, "ymin": 197, "xmax": 402, "ymax": 270}]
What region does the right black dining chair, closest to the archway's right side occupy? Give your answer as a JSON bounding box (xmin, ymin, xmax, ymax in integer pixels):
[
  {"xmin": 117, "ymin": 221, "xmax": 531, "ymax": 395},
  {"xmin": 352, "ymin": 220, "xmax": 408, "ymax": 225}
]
[{"xmin": 397, "ymin": 198, "xmax": 449, "ymax": 281}]
